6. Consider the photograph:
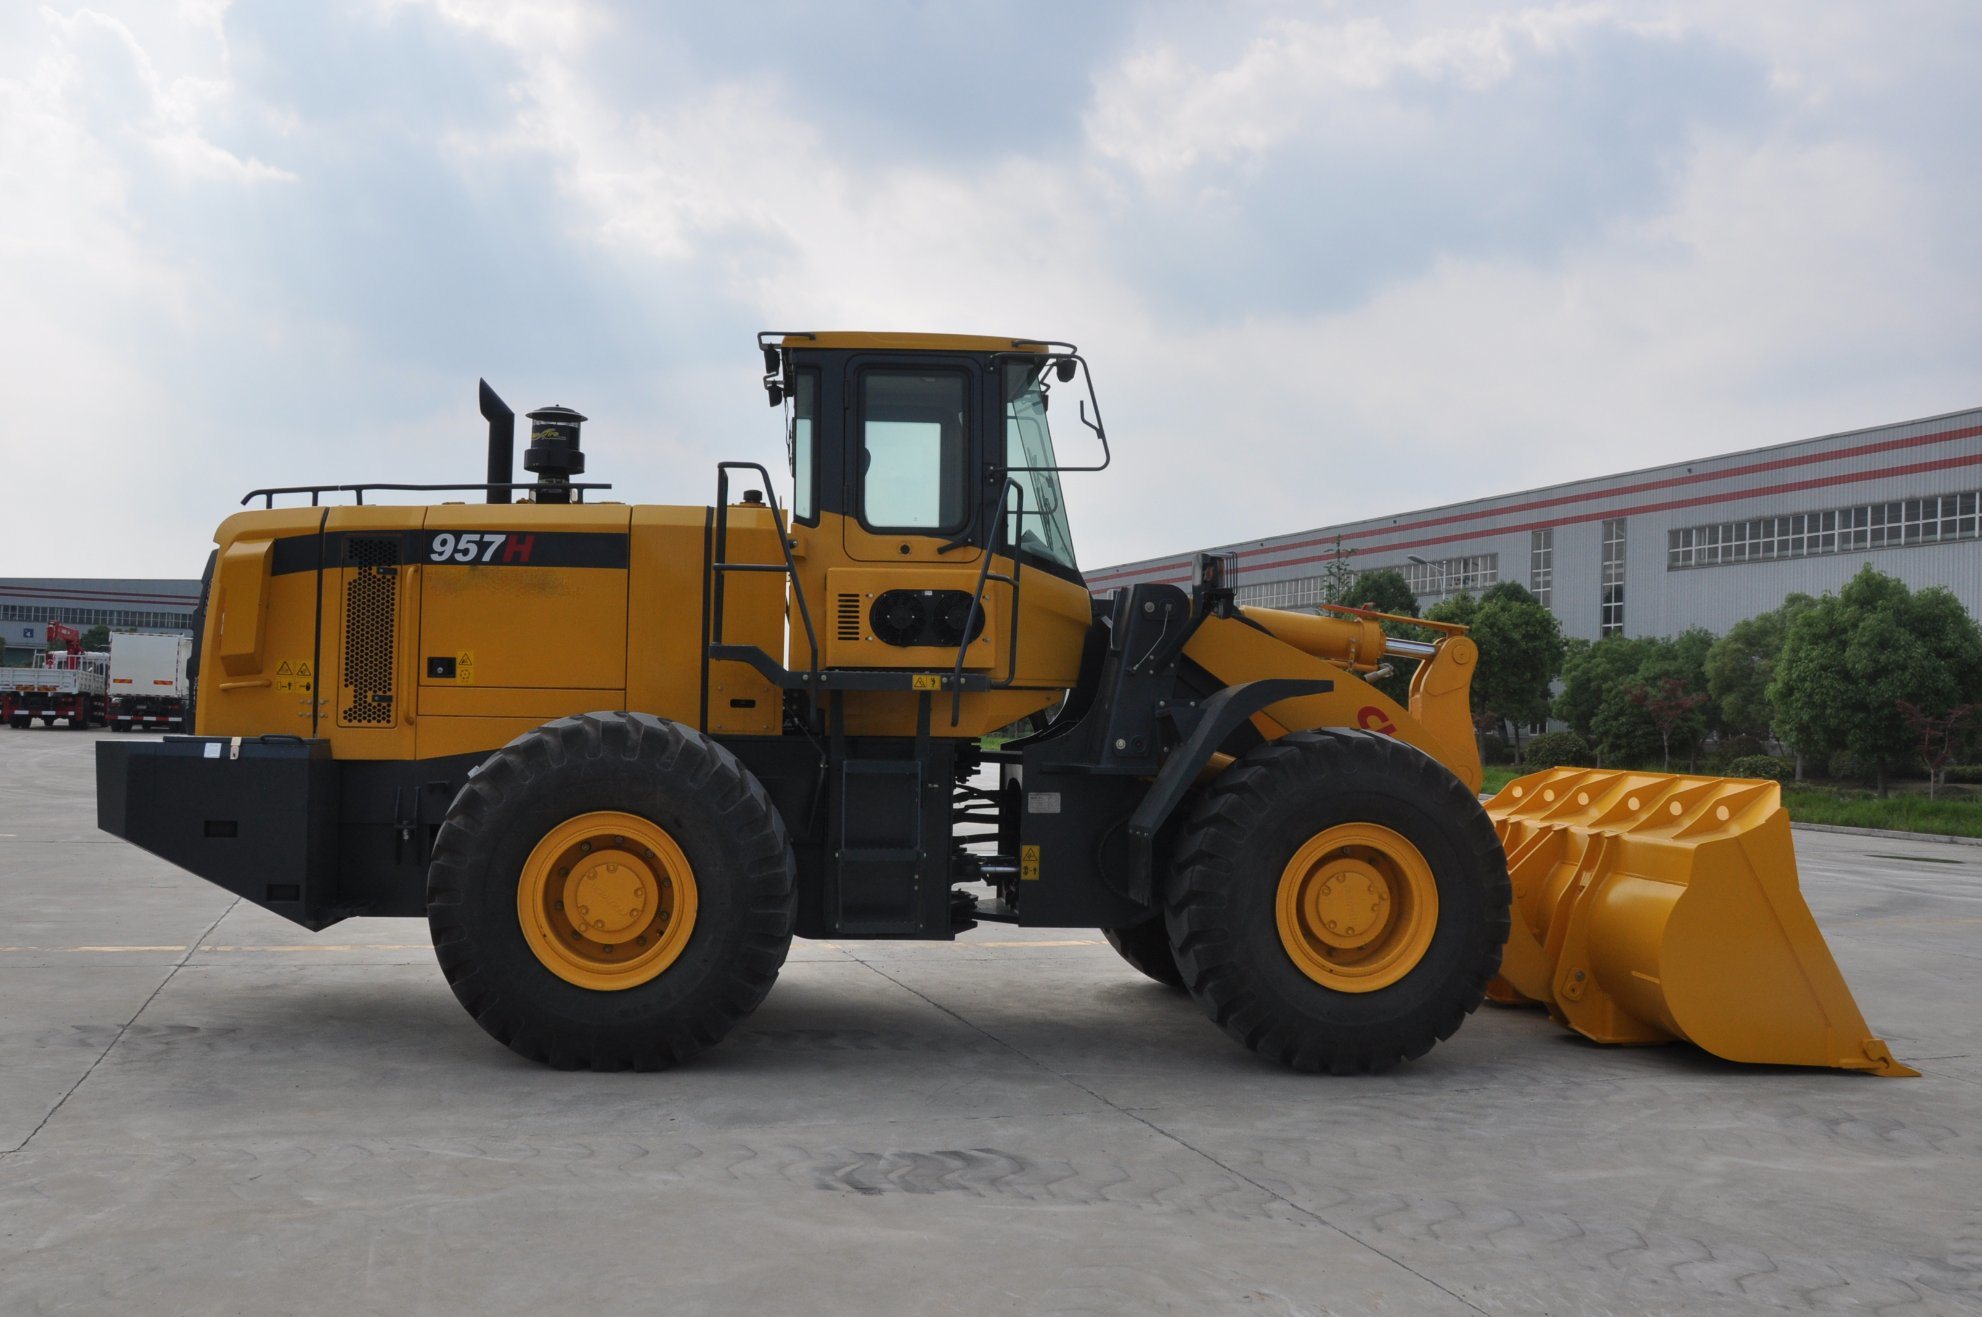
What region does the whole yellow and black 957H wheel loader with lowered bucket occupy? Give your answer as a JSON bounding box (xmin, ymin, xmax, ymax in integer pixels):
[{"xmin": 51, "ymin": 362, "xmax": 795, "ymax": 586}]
[{"xmin": 97, "ymin": 331, "xmax": 1905, "ymax": 1073}]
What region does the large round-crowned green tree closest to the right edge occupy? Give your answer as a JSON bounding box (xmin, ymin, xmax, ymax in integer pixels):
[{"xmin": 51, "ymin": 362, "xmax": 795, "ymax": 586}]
[{"xmin": 1768, "ymin": 563, "xmax": 1982, "ymax": 795}]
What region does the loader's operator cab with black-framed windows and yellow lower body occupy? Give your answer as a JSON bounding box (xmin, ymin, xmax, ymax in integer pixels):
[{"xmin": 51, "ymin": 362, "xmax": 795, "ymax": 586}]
[{"xmin": 757, "ymin": 333, "xmax": 1108, "ymax": 732}]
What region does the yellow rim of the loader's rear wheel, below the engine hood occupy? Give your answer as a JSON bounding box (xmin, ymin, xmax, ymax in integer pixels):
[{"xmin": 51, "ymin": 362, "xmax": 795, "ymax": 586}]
[{"xmin": 515, "ymin": 809, "xmax": 696, "ymax": 992}]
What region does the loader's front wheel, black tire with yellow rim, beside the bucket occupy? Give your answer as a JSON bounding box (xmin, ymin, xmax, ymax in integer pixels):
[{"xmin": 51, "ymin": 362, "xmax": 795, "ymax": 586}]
[{"xmin": 1165, "ymin": 732, "xmax": 1510, "ymax": 1075}]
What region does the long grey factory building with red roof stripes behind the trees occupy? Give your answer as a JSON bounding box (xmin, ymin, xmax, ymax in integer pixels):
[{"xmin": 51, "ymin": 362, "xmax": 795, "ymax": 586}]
[{"xmin": 1088, "ymin": 409, "xmax": 1982, "ymax": 641}]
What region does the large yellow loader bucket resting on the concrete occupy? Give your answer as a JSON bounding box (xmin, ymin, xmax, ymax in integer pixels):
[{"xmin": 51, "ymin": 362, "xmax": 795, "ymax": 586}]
[{"xmin": 1487, "ymin": 768, "xmax": 1919, "ymax": 1075}]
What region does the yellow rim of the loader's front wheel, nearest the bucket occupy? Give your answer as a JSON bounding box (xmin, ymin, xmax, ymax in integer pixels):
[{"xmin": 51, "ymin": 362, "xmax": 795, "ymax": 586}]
[{"xmin": 1274, "ymin": 823, "xmax": 1439, "ymax": 992}]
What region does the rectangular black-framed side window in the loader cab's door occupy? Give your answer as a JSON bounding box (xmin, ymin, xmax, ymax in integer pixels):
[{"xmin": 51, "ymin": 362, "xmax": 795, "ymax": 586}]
[{"xmin": 860, "ymin": 371, "xmax": 969, "ymax": 534}]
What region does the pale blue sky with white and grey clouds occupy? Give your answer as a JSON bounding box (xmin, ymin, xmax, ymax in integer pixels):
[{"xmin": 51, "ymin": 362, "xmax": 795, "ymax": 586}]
[{"xmin": 0, "ymin": 0, "xmax": 1982, "ymax": 577}]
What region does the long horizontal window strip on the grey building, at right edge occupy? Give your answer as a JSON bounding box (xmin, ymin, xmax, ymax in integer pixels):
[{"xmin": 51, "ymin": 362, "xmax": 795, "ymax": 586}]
[{"xmin": 1665, "ymin": 490, "xmax": 1982, "ymax": 571}]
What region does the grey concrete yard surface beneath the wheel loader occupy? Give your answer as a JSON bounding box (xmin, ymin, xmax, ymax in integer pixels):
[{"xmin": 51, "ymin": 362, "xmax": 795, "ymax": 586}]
[{"xmin": 0, "ymin": 728, "xmax": 1982, "ymax": 1313}]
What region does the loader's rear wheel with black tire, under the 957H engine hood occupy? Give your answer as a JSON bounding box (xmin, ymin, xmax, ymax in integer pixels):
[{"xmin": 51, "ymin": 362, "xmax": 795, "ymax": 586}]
[{"xmin": 426, "ymin": 714, "xmax": 797, "ymax": 1071}]
